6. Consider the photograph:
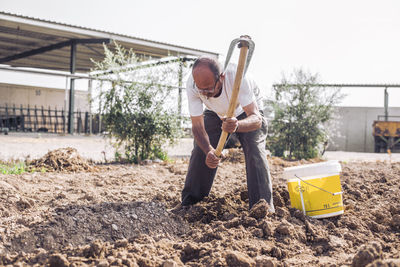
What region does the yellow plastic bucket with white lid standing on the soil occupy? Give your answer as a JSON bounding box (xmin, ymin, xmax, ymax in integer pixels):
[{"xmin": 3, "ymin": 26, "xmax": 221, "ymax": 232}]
[{"xmin": 283, "ymin": 161, "xmax": 343, "ymax": 219}]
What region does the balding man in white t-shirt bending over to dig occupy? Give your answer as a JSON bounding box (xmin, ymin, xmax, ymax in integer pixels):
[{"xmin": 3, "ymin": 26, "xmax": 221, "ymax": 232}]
[{"xmin": 181, "ymin": 57, "xmax": 274, "ymax": 212}]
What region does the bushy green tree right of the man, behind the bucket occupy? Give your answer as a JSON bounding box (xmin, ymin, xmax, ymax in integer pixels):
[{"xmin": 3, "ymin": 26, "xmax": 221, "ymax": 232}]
[{"xmin": 267, "ymin": 69, "xmax": 343, "ymax": 159}]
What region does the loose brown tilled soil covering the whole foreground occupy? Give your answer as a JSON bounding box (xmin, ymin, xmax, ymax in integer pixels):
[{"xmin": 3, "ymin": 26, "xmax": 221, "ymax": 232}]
[{"xmin": 0, "ymin": 149, "xmax": 400, "ymax": 266}]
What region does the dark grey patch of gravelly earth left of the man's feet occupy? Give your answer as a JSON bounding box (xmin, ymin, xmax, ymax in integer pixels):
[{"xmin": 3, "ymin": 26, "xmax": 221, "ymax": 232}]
[{"xmin": 11, "ymin": 202, "xmax": 189, "ymax": 252}]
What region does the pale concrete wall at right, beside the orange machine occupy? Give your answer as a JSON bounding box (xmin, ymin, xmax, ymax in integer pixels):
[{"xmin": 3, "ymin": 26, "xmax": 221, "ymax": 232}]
[{"xmin": 327, "ymin": 107, "xmax": 400, "ymax": 152}]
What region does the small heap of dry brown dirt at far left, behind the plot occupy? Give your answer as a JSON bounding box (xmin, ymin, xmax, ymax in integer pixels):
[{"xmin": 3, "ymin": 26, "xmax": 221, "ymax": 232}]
[{"xmin": 29, "ymin": 147, "xmax": 95, "ymax": 172}]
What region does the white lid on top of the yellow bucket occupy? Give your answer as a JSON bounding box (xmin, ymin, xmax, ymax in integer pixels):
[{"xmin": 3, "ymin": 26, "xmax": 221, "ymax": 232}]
[{"xmin": 283, "ymin": 160, "xmax": 342, "ymax": 179}]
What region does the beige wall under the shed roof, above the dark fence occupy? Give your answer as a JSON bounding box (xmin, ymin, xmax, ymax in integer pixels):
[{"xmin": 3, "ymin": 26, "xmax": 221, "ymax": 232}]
[{"xmin": 0, "ymin": 83, "xmax": 89, "ymax": 112}]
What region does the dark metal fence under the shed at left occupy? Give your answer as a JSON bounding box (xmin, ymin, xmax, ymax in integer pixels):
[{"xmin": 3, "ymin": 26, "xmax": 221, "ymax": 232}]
[{"xmin": 0, "ymin": 105, "xmax": 103, "ymax": 134}]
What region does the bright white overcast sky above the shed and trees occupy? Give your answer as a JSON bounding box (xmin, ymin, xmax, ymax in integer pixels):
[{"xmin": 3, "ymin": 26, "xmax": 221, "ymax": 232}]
[{"xmin": 0, "ymin": 0, "xmax": 400, "ymax": 107}]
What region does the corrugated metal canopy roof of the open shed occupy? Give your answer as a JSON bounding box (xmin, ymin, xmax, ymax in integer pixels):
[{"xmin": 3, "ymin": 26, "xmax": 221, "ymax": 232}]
[{"xmin": 0, "ymin": 12, "xmax": 218, "ymax": 72}]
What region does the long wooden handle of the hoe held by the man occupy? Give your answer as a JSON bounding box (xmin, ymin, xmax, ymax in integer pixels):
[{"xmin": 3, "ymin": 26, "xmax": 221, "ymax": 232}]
[{"xmin": 215, "ymin": 43, "xmax": 249, "ymax": 157}]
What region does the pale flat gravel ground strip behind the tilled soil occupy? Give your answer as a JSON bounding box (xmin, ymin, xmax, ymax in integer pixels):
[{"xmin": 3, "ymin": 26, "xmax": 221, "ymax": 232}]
[{"xmin": 0, "ymin": 133, "xmax": 400, "ymax": 162}]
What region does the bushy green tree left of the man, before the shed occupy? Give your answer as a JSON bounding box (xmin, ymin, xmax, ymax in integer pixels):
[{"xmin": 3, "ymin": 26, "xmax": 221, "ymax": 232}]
[{"xmin": 92, "ymin": 43, "xmax": 188, "ymax": 163}]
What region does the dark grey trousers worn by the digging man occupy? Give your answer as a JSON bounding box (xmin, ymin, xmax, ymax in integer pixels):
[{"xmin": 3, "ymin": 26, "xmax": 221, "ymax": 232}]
[{"xmin": 182, "ymin": 110, "xmax": 274, "ymax": 212}]
